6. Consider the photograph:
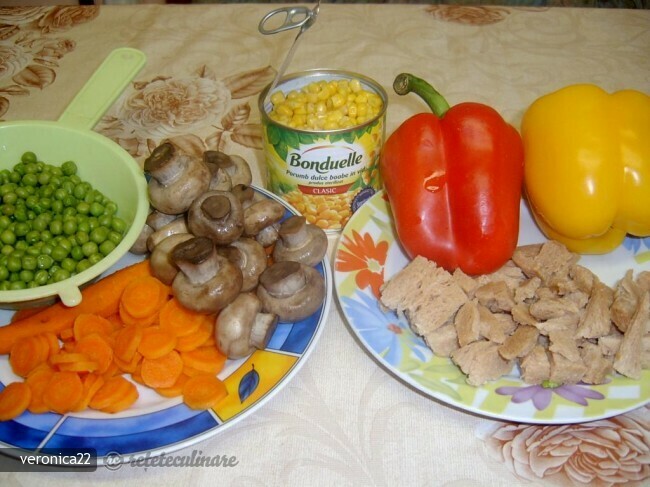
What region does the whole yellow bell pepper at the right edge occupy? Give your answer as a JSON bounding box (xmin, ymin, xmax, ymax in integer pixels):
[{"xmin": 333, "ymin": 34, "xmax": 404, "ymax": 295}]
[{"xmin": 521, "ymin": 84, "xmax": 650, "ymax": 254}]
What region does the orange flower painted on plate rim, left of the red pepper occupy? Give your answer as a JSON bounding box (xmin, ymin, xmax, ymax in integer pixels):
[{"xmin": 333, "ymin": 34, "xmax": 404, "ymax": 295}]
[{"xmin": 336, "ymin": 230, "xmax": 388, "ymax": 297}]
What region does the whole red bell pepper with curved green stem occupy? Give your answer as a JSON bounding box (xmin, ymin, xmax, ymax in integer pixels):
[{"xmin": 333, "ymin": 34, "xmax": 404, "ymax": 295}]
[{"xmin": 380, "ymin": 74, "xmax": 524, "ymax": 275}]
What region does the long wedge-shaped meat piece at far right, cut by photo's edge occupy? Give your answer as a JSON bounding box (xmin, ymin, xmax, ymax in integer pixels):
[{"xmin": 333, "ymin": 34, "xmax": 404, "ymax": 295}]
[{"xmin": 614, "ymin": 293, "xmax": 650, "ymax": 379}]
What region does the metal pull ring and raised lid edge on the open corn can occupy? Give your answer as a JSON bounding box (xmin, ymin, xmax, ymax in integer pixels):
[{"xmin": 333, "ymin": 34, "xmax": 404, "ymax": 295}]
[{"xmin": 258, "ymin": 0, "xmax": 320, "ymax": 99}]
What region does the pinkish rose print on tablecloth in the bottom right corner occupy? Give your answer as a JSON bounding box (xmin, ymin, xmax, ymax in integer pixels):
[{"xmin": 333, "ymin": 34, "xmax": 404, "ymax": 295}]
[{"xmin": 477, "ymin": 406, "xmax": 650, "ymax": 487}]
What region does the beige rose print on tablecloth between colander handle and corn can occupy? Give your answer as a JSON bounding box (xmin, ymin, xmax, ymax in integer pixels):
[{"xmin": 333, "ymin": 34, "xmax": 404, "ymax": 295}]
[{"xmin": 95, "ymin": 64, "xmax": 275, "ymax": 163}]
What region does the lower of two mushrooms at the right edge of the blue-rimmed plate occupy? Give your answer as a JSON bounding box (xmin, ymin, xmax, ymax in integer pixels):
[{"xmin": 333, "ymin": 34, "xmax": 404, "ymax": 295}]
[{"xmin": 257, "ymin": 261, "xmax": 325, "ymax": 321}]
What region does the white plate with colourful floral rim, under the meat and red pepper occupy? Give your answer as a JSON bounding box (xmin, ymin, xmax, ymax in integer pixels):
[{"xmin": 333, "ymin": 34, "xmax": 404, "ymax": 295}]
[{"xmin": 334, "ymin": 192, "xmax": 650, "ymax": 424}]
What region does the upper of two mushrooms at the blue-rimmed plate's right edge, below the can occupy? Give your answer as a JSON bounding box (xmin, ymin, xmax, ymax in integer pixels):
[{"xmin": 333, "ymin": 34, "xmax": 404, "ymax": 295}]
[{"xmin": 273, "ymin": 215, "xmax": 328, "ymax": 266}]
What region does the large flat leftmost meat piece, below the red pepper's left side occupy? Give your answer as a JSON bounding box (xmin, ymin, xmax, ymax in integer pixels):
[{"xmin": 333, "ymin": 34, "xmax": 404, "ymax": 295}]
[{"xmin": 380, "ymin": 256, "xmax": 467, "ymax": 335}]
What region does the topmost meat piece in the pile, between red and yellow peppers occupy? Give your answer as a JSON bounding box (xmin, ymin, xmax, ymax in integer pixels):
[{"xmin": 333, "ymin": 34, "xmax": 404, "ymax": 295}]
[{"xmin": 512, "ymin": 240, "xmax": 580, "ymax": 285}]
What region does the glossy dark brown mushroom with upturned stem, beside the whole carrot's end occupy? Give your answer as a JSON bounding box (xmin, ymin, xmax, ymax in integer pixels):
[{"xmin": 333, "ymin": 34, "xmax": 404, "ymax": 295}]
[{"xmin": 171, "ymin": 237, "xmax": 242, "ymax": 314}]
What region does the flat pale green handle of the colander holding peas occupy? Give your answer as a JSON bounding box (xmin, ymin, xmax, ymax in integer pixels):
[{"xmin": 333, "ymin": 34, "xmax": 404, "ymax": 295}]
[{"xmin": 58, "ymin": 47, "xmax": 147, "ymax": 130}]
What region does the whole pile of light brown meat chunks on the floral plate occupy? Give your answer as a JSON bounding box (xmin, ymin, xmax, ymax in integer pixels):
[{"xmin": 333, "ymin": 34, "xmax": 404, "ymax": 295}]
[{"xmin": 380, "ymin": 241, "xmax": 650, "ymax": 386}]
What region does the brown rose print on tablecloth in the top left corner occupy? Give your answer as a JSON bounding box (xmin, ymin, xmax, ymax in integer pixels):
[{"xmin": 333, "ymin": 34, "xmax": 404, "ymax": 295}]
[{"xmin": 0, "ymin": 6, "xmax": 99, "ymax": 117}]
